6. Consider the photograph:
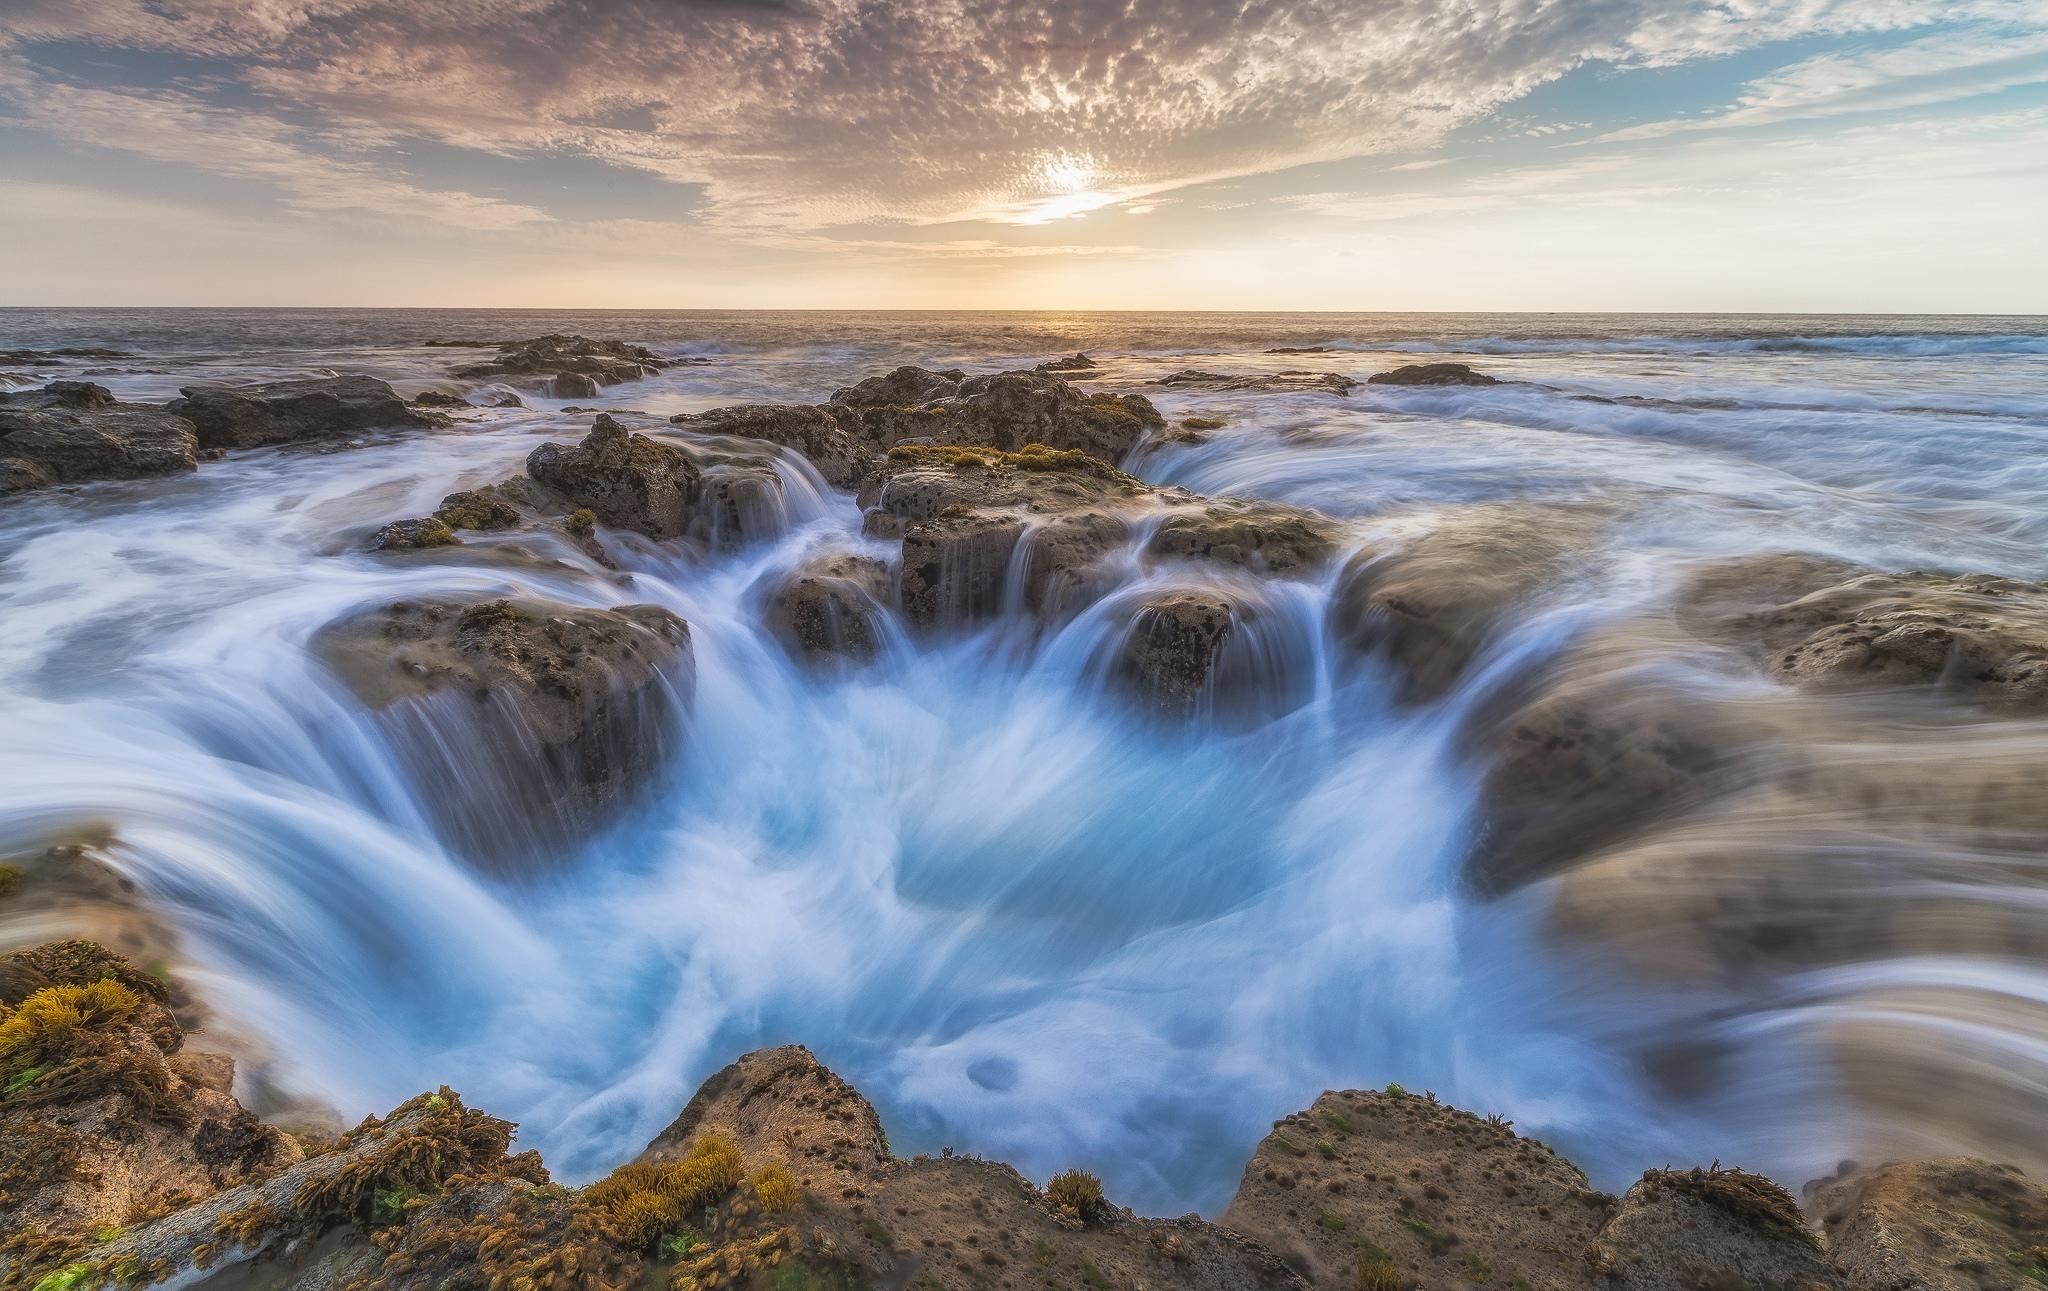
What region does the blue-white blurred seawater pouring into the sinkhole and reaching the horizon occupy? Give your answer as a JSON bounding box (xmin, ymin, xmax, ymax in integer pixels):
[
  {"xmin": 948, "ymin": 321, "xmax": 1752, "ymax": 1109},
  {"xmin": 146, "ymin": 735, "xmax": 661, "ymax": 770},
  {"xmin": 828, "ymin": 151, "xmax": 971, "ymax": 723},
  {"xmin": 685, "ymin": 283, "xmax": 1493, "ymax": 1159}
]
[{"xmin": 0, "ymin": 309, "xmax": 2048, "ymax": 1213}]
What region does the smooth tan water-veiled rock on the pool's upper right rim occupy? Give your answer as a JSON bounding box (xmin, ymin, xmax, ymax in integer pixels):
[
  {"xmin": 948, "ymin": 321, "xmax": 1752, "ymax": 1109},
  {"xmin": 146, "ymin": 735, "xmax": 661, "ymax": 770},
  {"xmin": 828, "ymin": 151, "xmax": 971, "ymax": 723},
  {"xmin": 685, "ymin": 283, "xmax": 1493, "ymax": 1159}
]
[{"xmin": 1331, "ymin": 504, "xmax": 1599, "ymax": 703}]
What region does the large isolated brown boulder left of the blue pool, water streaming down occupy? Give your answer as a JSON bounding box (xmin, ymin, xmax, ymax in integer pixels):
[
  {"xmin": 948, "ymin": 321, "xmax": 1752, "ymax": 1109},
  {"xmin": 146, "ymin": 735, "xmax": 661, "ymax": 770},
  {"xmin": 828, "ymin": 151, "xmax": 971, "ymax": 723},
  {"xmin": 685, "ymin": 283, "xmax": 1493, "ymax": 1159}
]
[{"xmin": 313, "ymin": 600, "xmax": 690, "ymax": 869}]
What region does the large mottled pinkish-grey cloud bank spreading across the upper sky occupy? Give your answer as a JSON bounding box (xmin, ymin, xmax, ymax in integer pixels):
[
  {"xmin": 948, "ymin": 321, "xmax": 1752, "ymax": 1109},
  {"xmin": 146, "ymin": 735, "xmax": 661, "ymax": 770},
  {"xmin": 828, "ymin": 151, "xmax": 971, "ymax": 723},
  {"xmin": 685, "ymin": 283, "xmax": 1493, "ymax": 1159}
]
[{"xmin": 0, "ymin": 0, "xmax": 2038, "ymax": 236}]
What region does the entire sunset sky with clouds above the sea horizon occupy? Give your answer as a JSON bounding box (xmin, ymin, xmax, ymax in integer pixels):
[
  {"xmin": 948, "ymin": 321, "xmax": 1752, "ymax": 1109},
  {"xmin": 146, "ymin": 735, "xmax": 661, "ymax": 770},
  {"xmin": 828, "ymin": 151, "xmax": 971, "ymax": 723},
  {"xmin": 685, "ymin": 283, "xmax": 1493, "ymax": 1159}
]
[{"xmin": 0, "ymin": 0, "xmax": 2048, "ymax": 314}]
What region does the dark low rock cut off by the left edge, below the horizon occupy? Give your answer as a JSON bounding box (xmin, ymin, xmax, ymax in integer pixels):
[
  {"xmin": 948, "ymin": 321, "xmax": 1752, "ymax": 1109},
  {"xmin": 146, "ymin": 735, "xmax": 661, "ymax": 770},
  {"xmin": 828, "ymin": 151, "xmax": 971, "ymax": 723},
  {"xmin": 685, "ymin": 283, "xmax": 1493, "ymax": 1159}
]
[{"xmin": 0, "ymin": 381, "xmax": 199, "ymax": 496}]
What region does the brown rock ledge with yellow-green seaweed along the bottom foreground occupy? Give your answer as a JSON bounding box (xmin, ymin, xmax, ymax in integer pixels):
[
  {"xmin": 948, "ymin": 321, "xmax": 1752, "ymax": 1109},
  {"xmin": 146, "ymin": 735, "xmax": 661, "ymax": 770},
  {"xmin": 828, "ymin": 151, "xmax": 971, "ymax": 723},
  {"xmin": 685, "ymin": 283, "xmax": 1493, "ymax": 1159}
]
[{"xmin": 0, "ymin": 943, "xmax": 2048, "ymax": 1291}]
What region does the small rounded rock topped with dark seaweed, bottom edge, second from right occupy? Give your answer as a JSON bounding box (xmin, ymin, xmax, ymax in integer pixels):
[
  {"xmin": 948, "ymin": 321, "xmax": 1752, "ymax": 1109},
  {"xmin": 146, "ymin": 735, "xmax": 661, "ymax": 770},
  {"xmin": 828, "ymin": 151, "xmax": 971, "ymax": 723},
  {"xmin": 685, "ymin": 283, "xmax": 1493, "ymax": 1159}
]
[{"xmin": 1585, "ymin": 1168, "xmax": 1845, "ymax": 1291}]
